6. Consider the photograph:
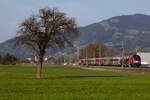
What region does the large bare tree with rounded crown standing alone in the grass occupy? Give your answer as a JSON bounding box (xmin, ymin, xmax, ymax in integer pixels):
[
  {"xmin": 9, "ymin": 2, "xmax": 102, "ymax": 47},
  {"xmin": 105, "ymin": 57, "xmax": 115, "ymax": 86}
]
[{"xmin": 16, "ymin": 8, "xmax": 78, "ymax": 78}]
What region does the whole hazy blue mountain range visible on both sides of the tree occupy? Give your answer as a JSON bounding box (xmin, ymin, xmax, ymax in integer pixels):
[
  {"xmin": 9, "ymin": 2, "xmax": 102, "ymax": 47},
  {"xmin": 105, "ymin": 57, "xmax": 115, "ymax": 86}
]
[{"xmin": 0, "ymin": 14, "xmax": 150, "ymax": 57}]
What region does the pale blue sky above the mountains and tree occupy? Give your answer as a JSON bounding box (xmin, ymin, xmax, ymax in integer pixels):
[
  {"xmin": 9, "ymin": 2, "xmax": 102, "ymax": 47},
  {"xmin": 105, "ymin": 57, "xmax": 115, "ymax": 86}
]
[{"xmin": 0, "ymin": 0, "xmax": 150, "ymax": 42}]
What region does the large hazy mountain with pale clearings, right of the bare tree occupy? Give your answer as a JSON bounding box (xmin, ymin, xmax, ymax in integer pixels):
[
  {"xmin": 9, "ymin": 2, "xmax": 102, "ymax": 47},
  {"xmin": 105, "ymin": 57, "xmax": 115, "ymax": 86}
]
[{"xmin": 79, "ymin": 14, "xmax": 150, "ymax": 49}]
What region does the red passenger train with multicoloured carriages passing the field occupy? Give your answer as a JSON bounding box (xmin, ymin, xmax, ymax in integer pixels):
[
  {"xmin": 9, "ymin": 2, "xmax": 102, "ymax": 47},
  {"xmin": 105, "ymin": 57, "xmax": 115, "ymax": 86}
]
[{"xmin": 79, "ymin": 55, "xmax": 141, "ymax": 67}]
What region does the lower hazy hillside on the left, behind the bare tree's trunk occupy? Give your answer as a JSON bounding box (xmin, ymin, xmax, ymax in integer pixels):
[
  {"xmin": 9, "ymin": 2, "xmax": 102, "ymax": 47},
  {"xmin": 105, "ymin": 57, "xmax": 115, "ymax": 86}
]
[{"xmin": 0, "ymin": 38, "xmax": 58, "ymax": 58}]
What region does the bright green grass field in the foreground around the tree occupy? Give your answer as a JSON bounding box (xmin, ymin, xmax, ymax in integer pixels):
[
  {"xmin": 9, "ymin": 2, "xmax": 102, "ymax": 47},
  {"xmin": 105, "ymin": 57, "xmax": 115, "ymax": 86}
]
[{"xmin": 0, "ymin": 65, "xmax": 150, "ymax": 100}]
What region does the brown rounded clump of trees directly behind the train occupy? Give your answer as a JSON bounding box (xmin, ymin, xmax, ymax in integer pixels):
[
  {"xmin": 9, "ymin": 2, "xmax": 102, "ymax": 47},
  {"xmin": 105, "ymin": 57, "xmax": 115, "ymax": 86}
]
[{"xmin": 79, "ymin": 43, "xmax": 115, "ymax": 59}]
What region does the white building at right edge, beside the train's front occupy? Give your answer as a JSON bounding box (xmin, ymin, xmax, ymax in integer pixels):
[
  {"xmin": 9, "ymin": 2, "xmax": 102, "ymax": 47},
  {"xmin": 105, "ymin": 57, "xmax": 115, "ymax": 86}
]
[{"xmin": 137, "ymin": 52, "xmax": 150, "ymax": 67}]
